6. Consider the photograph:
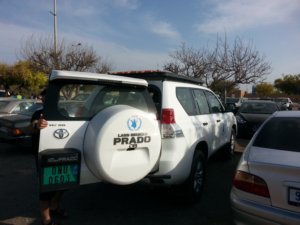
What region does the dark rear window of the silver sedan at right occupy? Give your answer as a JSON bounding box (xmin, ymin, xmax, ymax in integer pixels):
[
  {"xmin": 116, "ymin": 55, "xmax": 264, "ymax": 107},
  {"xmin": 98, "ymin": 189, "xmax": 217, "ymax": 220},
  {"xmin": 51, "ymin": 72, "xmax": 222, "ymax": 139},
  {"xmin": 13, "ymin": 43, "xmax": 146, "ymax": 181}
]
[{"xmin": 253, "ymin": 117, "xmax": 300, "ymax": 152}]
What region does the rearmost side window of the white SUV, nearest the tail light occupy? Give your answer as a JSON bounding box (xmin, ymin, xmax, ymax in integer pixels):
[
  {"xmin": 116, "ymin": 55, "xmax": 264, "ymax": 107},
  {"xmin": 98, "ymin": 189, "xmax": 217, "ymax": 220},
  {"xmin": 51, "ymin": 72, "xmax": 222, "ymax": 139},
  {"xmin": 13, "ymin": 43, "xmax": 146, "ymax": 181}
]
[{"xmin": 176, "ymin": 88, "xmax": 198, "ymax": 116}]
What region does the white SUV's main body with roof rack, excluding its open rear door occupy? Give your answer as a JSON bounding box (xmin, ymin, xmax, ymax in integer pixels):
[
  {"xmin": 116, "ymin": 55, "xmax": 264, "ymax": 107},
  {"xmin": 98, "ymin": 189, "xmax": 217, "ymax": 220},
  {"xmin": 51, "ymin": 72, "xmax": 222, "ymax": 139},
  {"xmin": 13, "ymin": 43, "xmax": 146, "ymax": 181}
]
[{"xmin": 113, "ymin": 71, "xmax": 237, "ymax": 201}]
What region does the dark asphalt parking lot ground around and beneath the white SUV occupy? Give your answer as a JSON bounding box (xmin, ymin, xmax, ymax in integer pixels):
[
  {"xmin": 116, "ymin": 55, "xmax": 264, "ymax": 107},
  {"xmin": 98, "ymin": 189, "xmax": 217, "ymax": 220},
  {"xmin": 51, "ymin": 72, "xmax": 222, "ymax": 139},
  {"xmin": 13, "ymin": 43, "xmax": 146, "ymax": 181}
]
[{"xmin": 0, "ymin": 140, "xmax": 247, "ymax": 225}]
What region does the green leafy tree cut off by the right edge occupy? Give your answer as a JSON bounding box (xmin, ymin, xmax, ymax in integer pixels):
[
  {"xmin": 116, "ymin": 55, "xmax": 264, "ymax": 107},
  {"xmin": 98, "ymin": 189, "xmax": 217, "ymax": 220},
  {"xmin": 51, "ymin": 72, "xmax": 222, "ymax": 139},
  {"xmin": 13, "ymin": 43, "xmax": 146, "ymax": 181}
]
[{"xmin": 274, "ymin": 74, "xmax": 300, "ymax": 95}]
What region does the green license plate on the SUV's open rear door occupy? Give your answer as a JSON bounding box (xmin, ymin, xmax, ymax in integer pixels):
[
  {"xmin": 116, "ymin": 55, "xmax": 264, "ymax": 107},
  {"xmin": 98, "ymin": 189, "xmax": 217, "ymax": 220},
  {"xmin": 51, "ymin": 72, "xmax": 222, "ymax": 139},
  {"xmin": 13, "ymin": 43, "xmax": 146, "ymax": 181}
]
[{"xmin": 42, "ymin": 164, "xmax": 79, "ymax": 186}]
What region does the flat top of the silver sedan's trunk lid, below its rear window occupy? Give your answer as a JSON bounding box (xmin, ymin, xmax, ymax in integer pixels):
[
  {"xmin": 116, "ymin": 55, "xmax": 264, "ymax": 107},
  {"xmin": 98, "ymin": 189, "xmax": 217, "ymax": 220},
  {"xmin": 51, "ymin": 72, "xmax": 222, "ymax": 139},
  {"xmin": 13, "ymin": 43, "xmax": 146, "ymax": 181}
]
[{"xmin": 248, "ymin": 146, "xmax": 300, "ymax": 169}]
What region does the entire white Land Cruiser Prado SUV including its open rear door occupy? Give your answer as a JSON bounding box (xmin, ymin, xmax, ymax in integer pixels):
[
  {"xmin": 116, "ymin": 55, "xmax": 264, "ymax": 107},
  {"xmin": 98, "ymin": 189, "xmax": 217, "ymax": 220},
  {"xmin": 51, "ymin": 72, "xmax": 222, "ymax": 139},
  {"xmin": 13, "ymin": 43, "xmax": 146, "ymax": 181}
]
[{"xmin": 39, "ymin": 71, "xmax": 237, "ymax": 200}]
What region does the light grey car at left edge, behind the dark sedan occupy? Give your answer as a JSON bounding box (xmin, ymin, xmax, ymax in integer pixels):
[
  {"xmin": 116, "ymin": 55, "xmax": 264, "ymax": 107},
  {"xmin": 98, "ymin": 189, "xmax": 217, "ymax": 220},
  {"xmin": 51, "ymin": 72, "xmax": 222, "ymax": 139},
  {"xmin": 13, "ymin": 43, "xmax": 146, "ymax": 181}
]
[{"xmin": 0, "ymin": 97, "xmax": 37, "ymax": 117}]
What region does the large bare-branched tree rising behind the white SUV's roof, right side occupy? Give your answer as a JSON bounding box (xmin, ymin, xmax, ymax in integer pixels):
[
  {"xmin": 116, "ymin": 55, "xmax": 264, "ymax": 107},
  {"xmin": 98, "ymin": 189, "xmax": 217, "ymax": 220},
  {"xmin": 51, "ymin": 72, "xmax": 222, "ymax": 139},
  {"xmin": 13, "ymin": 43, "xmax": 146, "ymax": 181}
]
[{"xmin": 163, "ymin": 36, "xmax": 271, "ymax": 89}]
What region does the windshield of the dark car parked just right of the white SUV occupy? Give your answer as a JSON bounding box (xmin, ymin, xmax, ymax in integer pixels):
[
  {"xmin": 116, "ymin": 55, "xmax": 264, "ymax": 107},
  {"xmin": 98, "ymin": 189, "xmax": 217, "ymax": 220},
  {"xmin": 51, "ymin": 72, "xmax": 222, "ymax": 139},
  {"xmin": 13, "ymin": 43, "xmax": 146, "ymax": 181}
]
[{"xmin": 239, "ymin": 102, "xmax": 278, "ymax": 114}]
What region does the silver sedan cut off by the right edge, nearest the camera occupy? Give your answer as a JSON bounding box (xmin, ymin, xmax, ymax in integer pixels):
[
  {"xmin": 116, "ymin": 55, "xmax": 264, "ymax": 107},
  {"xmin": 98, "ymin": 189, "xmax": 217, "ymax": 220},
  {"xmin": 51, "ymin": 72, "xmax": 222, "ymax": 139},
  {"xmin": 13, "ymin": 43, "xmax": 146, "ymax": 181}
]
[{"xmin": 230, "ymin": 111, "xmax": 300, "ymax": 225}]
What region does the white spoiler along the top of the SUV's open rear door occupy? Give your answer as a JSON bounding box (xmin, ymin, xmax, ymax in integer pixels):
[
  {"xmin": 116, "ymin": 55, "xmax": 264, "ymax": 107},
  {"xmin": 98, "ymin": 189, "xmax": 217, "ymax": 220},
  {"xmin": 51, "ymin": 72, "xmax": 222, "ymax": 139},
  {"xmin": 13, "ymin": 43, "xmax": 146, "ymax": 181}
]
[{"xmin": 49, "ymin": 70, "xmax": 148, "ymax": 86}]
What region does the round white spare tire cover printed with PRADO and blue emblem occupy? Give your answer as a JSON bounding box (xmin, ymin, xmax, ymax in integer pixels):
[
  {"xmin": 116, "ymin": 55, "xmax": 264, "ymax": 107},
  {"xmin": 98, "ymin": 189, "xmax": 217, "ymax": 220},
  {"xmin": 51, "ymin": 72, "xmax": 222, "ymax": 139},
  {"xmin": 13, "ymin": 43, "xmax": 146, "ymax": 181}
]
[{"xmin": 84, "ymin": 105, "xmax": 161, "ymax": 184}]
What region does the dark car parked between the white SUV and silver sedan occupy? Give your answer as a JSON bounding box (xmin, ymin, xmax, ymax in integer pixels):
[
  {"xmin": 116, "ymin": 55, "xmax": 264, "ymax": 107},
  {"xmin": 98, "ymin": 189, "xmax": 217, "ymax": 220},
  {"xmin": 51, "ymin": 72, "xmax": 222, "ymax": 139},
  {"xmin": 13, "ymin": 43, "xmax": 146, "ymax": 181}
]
[{"xmin": 235, "ymin": 100, "xmax": 280, "ymax": 138}]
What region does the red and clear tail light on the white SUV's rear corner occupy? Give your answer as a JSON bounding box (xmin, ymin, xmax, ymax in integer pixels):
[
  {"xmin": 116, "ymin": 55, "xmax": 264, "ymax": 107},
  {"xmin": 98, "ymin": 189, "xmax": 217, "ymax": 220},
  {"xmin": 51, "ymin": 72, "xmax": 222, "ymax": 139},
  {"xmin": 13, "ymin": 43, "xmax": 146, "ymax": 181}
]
[{"xmin": 161, "ymin": 108, "xmax": 183, "ymax": 138}]
